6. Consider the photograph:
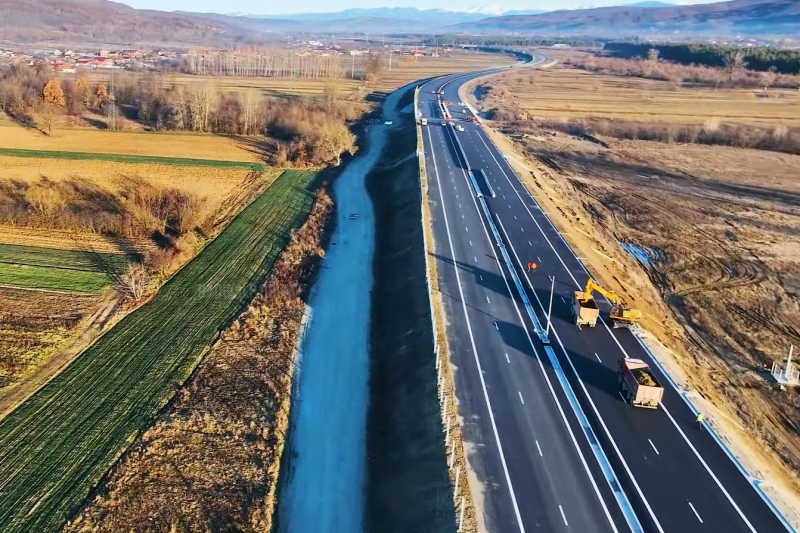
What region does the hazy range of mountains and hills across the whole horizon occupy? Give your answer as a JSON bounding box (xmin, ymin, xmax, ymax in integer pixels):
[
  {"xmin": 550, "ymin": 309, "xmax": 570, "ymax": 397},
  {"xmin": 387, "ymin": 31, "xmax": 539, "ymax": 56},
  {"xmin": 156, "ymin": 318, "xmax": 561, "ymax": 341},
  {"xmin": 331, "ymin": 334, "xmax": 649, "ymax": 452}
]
[{"xmin": 0, "ymin": 0, "xmax": 800, "ymax": 47}]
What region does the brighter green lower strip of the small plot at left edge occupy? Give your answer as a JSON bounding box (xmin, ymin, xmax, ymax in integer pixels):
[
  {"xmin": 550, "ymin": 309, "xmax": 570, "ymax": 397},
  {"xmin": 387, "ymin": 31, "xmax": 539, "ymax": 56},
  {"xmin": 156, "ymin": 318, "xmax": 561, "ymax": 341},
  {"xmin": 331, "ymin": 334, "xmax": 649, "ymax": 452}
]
[{"xmin": 0, "ymin": 263, "xmax": 111, "ymax": 294}]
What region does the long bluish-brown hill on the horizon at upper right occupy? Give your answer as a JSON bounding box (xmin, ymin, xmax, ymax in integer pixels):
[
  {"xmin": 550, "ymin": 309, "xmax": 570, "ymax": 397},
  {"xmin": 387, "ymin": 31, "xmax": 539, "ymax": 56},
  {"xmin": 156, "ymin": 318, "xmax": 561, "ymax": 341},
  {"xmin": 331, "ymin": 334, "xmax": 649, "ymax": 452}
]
[{"xmin": 459, "ymin": 0, "xmax": 800, "ymax": 35}]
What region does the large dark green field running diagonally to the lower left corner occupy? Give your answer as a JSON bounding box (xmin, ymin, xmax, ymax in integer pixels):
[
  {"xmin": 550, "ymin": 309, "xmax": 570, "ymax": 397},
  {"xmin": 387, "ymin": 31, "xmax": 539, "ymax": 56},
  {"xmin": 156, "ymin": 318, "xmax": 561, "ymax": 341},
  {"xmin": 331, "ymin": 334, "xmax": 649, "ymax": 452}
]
[{"xmin": 0, "ymin": 171, "xmax": 314, "ymax": 533}]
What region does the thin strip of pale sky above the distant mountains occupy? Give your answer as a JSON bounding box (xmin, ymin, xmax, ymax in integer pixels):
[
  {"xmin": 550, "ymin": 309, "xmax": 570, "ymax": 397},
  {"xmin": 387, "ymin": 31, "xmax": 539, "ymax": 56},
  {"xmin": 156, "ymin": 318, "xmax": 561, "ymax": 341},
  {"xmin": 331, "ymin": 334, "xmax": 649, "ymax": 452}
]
[{"xmin": 122, "ymin": 0, "xmax": 715, "ymax": 15}]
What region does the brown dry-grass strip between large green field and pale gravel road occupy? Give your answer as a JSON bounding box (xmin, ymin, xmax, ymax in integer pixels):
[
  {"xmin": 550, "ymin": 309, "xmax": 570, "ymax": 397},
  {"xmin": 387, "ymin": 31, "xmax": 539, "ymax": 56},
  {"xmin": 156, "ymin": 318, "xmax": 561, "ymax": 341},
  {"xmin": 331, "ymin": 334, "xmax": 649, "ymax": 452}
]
[{"xmin": 64, "ymin": 190, "xmax": 333, "ymax": 533}]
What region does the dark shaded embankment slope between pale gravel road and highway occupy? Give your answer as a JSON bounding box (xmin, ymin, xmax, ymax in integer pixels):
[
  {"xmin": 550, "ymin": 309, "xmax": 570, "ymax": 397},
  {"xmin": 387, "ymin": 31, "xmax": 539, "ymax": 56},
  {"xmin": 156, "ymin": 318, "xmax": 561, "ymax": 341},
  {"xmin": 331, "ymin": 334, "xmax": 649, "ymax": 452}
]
[{"xmin": 365, "ymin": 92, "xmax": 456, "ymax": 533}]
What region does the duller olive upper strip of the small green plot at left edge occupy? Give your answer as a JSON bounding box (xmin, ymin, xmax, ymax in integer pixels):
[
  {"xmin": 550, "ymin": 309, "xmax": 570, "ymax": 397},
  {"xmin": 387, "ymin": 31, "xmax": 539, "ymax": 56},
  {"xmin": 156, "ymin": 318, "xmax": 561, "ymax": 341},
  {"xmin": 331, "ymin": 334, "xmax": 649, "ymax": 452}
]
[{"xmin": 0, "ymin": 244, "xmax": 131, "ymax": 272}]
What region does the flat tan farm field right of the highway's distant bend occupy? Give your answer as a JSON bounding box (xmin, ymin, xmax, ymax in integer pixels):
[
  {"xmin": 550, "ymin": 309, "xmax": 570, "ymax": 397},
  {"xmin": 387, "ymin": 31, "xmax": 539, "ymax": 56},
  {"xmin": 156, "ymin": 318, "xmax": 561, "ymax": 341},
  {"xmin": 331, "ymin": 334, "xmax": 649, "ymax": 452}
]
[{"xmin": 487, "ymin": 63, "xmax": 800, "ymax": 127}]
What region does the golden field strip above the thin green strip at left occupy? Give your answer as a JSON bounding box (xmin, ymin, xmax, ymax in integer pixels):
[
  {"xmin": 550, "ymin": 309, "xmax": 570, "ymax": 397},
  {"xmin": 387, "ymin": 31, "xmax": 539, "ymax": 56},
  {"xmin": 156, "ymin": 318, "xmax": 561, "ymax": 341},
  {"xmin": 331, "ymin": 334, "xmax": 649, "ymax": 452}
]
[{"xmin": 0, "ymin": 117, "xmax": 259, "ymax": 162}]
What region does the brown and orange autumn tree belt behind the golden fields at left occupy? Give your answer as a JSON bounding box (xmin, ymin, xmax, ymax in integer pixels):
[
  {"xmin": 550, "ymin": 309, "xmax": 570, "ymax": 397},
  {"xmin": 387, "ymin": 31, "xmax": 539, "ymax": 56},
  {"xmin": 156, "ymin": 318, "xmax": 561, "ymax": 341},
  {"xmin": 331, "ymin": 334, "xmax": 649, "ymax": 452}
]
[{"xmin": 0, "ymin": 66, "xmax": 360, "ymax": 166}]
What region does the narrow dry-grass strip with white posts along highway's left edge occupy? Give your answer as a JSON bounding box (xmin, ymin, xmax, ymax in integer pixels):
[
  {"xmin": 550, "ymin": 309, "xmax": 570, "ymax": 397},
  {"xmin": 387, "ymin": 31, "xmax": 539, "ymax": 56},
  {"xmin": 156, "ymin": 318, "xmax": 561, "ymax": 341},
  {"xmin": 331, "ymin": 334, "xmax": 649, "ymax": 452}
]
[{"xmin": 414, "ymin": 87, "xmax": 478, "ymax": 533}]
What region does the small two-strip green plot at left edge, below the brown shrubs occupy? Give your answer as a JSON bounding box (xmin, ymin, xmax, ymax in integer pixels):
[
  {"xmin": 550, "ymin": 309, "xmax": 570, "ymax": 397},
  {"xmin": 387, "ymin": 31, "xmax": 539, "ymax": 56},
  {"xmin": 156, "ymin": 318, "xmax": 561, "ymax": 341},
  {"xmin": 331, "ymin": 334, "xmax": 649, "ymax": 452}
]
[{"xmin": 0, "ymin": 244, "xmax": 130, "ymax": 294}]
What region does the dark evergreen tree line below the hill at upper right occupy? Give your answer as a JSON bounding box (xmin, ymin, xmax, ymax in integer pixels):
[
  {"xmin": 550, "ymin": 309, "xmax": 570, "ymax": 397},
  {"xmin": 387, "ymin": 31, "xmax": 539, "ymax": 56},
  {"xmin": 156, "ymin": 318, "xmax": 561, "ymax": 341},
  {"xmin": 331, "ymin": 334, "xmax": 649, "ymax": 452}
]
[{"xmin": 603, "ymin": 42, "xmax": 800, "ymax": 74}]
